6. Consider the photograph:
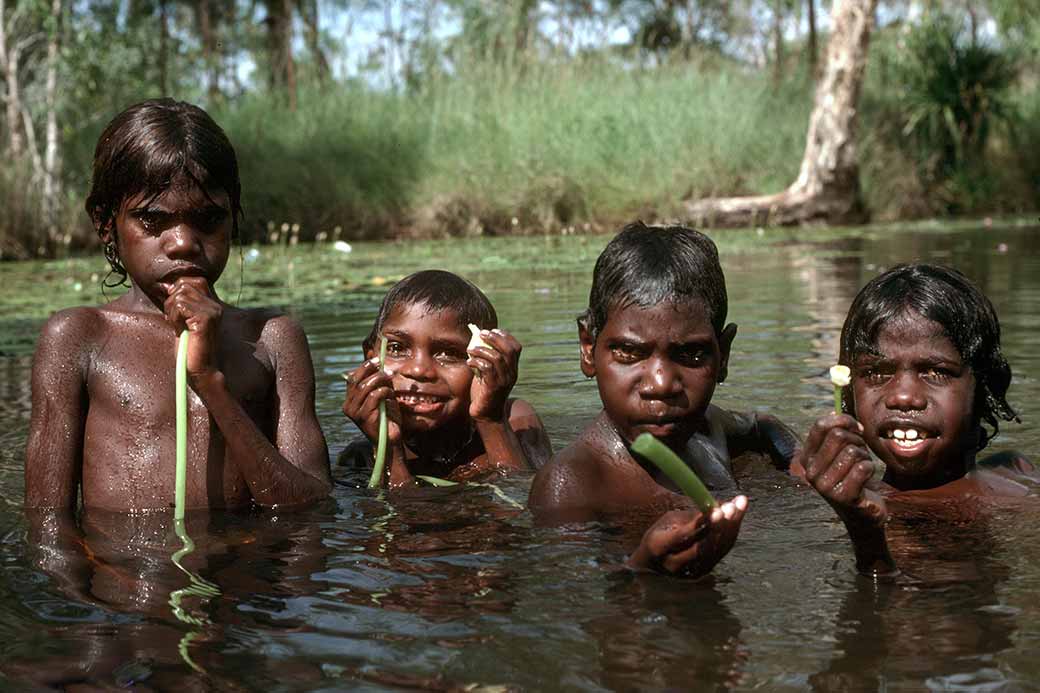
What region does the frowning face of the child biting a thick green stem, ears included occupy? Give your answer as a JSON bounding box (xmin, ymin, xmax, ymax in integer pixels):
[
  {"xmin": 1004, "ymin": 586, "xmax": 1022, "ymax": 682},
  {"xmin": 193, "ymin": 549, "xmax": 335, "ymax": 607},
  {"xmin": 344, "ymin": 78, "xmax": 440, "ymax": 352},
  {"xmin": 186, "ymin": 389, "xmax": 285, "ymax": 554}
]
[{"xmin": 579, "ymin": 301, "xmax": 736, "ymax": 445}]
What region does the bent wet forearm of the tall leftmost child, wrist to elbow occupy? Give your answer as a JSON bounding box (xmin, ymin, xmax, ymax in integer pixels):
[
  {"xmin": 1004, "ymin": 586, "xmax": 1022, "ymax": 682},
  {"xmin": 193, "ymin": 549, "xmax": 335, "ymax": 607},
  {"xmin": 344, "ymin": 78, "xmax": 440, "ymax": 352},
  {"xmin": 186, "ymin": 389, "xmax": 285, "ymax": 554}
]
[{"xmin": 192, "ymin": 373, "xmax": 331, "ymax": 506}]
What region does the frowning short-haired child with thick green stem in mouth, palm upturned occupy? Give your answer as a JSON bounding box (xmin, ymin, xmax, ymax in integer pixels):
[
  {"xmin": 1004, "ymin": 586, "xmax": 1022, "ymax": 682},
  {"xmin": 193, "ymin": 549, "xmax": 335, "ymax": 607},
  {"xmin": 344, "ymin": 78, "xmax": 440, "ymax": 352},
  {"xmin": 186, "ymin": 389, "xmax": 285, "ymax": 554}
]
[{"xmin": 529, "ymin": 223, "xmax": 798, "ymax": 576}]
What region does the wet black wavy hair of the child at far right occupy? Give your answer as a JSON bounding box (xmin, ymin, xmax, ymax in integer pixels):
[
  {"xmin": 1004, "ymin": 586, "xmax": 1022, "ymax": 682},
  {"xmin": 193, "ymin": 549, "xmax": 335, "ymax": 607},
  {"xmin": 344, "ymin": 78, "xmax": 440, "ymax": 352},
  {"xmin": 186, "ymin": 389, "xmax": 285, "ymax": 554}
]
[{"xmin": 838, "ymin": 263, "xmax": 1019, "ymax": 450}]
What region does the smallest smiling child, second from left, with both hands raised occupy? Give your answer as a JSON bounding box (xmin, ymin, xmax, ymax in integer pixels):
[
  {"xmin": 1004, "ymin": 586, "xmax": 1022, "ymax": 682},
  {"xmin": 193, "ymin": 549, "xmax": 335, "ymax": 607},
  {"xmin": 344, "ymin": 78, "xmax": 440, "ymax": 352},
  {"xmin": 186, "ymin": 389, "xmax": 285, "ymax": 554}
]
[{"xmin": 340, "ymin": 270, "xmax": 552, "ymax": 488}]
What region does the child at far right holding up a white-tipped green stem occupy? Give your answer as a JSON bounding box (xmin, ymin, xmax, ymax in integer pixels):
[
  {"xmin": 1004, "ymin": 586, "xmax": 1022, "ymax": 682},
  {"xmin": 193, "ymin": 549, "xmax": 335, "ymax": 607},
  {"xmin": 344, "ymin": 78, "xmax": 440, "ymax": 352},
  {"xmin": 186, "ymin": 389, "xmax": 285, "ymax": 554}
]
[{"xmin": 792, "ymin": 264, "xmax": 1038, "ymax": 574}]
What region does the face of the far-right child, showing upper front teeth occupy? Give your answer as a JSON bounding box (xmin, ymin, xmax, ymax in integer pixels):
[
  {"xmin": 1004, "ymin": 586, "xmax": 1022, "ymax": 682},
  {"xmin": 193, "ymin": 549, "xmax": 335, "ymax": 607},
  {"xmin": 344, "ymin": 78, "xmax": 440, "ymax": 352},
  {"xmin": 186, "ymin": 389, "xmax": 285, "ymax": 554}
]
[{"xmin": 852, "ymin": 313, "xmax": 979, "ymax": 482}]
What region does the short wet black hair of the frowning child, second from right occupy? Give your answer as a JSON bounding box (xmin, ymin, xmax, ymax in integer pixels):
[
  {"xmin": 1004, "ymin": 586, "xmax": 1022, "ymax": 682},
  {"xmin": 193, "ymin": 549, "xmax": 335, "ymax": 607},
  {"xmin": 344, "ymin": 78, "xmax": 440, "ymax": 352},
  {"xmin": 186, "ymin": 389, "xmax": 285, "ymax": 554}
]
[{"xmin": 578, "ymin": 222, "xmax": 728, "ymax": 339}]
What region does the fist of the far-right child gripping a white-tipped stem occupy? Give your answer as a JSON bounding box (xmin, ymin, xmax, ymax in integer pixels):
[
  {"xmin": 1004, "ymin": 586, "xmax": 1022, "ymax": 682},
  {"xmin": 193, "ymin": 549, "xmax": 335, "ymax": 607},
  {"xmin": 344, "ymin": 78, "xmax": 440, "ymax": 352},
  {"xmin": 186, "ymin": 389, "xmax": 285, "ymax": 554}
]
[{"xmin": 795, "ymin": 414, "xmax": 888, "ymax": 529}]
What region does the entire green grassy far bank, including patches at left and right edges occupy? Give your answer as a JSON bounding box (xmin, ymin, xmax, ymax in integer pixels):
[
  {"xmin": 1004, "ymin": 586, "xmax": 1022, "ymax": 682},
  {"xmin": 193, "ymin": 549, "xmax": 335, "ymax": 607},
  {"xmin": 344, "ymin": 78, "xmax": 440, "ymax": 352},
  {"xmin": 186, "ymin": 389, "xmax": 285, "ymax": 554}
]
[{"xmin": 8, "ymin": 52, "xmax": 1040, "ymax": 258}]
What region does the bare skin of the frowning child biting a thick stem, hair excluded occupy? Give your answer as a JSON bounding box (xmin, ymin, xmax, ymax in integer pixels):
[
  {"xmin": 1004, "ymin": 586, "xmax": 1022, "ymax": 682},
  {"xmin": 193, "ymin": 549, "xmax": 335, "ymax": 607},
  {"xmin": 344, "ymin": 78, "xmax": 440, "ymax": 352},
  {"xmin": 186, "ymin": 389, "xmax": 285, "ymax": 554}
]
[{"xmin": 529, "ymin": 301, "xmax": 797, "ymax": 576}]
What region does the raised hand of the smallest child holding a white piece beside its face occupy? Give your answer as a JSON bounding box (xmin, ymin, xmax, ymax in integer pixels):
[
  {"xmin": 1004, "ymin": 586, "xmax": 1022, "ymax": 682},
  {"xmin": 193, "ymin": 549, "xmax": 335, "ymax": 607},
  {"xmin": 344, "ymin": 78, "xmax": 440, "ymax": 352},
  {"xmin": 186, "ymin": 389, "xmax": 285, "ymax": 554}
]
[{"xmin": 466, "ymin": 330, "xmax": 521, "ymax": 422}]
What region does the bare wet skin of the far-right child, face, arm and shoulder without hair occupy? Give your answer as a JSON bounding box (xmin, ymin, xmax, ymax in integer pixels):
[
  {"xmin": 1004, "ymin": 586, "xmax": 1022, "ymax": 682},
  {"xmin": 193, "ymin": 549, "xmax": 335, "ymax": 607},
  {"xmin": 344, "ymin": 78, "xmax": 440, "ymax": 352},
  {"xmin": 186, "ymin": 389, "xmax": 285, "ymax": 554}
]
[{"xmin": 792, "ymin": 313, "xmax": 1040, "ymax": 573}]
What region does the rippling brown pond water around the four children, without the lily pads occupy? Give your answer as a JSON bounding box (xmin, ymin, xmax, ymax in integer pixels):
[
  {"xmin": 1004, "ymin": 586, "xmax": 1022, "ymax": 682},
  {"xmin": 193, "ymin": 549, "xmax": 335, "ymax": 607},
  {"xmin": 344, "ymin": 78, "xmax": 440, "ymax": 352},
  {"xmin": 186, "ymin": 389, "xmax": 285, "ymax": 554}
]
[{"xmin": 0, "ymin": 223, "xmax": 1040, "ymax": 691}]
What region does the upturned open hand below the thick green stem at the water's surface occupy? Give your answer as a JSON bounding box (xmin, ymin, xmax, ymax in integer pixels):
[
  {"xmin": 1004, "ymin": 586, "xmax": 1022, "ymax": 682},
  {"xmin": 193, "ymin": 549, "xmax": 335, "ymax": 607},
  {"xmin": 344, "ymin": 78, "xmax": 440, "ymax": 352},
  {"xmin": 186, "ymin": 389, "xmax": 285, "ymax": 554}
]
[{"xmin": 627, "ymin": 495, "xmax": 748, "ymax": 578}]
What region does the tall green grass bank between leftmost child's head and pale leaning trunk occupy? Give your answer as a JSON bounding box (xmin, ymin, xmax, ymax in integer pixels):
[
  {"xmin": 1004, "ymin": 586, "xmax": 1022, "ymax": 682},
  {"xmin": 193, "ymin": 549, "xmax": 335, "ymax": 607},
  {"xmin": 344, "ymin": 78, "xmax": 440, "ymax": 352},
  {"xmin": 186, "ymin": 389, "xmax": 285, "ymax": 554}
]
[{"xmin": 216, "ymin": 60, "xmax": 809, "ymax": 239}]
